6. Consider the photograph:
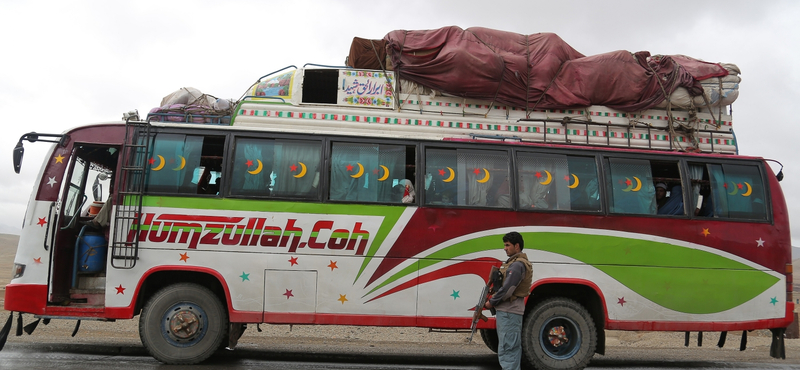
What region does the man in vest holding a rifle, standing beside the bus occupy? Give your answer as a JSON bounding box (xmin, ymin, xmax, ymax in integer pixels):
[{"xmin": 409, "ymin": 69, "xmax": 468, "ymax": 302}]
[{"xmin": 484, "ymin": 231, "xmax": 533, "ymax": 370}]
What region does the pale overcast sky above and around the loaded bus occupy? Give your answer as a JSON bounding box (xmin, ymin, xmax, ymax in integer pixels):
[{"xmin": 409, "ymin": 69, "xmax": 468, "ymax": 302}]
[{"xmin": 0, "ymin": 0, "xmax": 800, "ymax": 246}]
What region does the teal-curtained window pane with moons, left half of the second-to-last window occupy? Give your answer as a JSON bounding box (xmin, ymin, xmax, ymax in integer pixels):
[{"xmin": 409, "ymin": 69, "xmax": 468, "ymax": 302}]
[{"xmin": 606, "ymin": 158, "xmax": 657, "ymax": 215}]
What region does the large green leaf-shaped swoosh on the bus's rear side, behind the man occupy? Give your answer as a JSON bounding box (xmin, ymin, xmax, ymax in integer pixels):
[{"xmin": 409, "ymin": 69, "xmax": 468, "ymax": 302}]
[{"xmin": 368, "ymin": 232, "xmax": 779, "ymax": 314}]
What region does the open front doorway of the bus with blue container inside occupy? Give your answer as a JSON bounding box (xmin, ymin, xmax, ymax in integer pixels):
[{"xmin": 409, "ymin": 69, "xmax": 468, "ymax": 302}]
[{"xmin": 48, "ymin": 143, "xmax": 119, "ymax": 307}]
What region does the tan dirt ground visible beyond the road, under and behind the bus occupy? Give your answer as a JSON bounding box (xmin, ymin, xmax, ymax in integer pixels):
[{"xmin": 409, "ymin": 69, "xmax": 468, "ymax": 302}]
[{"xmin": 0, "ymin": 234, "xmax": 800, "ymax": 364}]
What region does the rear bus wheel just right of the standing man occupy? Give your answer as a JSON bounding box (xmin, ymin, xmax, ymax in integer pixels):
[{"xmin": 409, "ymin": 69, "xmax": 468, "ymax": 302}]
[{"xmin": 522, "ymin": 298, "xmax": 597, "ymax": 370}]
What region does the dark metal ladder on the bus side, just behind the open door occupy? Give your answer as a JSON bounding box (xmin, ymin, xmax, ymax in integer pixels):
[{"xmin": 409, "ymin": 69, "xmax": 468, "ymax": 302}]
[{"xmin": 111, "ymin": 116, "xmax": 152, "ymax": 269}]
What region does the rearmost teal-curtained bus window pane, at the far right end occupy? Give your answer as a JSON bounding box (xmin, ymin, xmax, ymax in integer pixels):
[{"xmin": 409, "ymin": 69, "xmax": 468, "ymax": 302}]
[{"xmin": 708, "ymin": 164, "xmax": 767, "ymax": 220}]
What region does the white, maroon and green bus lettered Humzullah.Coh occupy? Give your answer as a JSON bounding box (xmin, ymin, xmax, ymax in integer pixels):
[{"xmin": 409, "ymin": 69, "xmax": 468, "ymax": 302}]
[{"xmin": 5, "ymin": 65, "xmax": 794, "ymax": 369}]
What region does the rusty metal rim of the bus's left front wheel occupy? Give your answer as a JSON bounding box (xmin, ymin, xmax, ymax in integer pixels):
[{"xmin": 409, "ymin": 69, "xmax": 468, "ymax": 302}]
[{"xmin": 161, "ymin": 302, "xmax": 208, "ymax": 347}]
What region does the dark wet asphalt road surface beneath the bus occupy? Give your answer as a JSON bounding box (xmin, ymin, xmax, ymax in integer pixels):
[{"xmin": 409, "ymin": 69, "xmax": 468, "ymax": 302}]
[{"xmin": 0, "ymin": 343, "xmax": 800, "ymax": 370}]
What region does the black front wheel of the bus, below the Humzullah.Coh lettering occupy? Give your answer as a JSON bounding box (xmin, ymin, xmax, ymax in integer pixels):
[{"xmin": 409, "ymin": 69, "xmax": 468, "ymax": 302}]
[{"xmin": 139, "ymin": 283, "xmax": 228, "ymax": 365}]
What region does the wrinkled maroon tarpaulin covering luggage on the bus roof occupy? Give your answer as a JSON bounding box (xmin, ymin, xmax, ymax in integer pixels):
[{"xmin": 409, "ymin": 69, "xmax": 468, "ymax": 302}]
[{"xmin": 384, "ymin": 26, "xmax": 728, "ymax": 111}]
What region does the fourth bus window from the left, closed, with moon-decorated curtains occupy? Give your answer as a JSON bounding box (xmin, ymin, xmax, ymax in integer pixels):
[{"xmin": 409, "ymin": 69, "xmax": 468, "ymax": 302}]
[{"xmin": 425, "ymin": 149, "xmax": 511, "ymax": 208}]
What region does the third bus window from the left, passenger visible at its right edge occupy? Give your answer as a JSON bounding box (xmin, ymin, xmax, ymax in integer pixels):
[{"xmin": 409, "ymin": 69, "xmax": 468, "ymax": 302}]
[{"xmin": 330, "ymin": 142, "xmax": 416, "ymax": 204}]
